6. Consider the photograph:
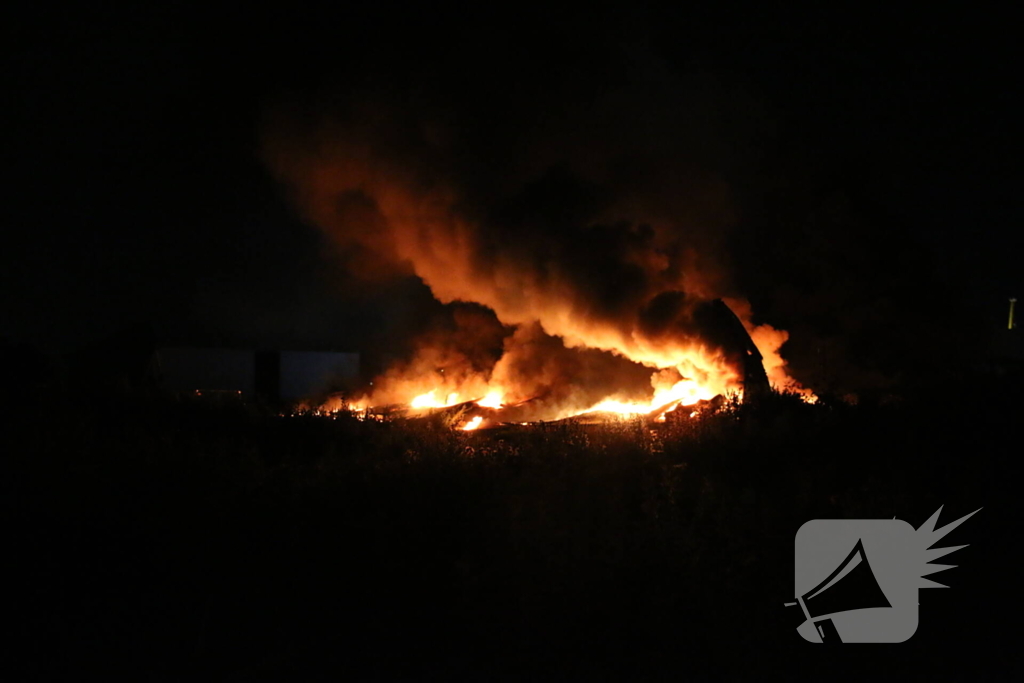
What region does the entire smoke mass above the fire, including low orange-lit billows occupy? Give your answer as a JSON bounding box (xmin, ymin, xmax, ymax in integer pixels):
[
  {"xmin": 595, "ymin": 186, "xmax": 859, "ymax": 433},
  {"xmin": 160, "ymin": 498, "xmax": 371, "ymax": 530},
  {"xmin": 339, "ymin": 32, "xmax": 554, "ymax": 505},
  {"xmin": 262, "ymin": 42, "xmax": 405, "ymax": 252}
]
[{"xmin": 263, "ymin": 46, "xmax": 811, "ymax": 417}]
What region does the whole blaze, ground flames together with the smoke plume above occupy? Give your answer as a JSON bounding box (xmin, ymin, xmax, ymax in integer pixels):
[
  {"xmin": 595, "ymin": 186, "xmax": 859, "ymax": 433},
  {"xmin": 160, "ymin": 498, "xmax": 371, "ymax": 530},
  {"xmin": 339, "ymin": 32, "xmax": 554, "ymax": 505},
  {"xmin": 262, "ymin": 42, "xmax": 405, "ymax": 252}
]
[{"xmin": 263, "ymin": 80, "xmax": 812, "ymax": 428}]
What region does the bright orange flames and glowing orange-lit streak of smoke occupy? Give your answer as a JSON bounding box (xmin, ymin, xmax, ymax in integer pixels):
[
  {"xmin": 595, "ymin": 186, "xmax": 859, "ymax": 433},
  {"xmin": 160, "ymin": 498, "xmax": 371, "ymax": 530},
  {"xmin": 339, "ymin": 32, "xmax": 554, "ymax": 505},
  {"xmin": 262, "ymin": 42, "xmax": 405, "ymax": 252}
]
[{"xmin": 263, "ymin": 108, "xmax": 813, "ymax": 420}]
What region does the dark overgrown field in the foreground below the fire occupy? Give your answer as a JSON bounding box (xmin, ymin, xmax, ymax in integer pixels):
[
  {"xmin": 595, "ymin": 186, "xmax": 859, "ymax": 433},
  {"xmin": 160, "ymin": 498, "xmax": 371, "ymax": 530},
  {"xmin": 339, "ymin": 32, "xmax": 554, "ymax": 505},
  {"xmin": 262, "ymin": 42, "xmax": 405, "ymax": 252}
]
[{"xmin": 2, "ymin": 380, "xmax": 1021, "ymax": 681}]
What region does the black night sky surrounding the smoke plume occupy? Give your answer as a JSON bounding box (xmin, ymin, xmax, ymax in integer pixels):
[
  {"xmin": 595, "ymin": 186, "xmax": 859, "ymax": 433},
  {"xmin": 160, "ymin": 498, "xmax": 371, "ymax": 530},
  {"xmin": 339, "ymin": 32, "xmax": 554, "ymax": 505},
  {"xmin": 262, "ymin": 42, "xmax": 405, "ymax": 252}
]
[{"xmin": 6, "ymin": 3, "xmax": 1024, "ymax": 395}]
